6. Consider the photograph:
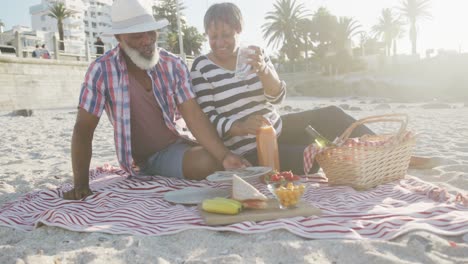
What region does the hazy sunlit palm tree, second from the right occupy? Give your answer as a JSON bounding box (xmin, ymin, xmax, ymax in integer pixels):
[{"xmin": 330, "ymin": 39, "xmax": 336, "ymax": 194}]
[{"xmin": 371, "ymin": 8, "xmax": 403, "ymax": 56}]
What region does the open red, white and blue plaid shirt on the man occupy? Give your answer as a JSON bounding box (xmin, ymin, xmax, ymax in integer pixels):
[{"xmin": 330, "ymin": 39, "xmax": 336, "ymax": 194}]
[{"xmin": 78, "ymin": 45, "xmax": 195, "ymax": 174}]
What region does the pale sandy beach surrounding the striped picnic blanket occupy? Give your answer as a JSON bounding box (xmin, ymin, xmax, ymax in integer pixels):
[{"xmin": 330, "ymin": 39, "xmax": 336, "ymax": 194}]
[{"xmin": 0, "ymin": 98, "xmax": 468, "ymax": 264}]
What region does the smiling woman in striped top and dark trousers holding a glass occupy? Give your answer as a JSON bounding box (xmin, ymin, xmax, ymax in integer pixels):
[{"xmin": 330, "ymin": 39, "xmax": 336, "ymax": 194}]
[{"xmin": 191, "ymin": 3, "xmax": 436, "ymax": 174}]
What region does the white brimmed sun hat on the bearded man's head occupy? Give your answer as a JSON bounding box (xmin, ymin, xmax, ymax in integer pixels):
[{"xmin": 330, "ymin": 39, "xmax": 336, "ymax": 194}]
[{"xmin": 102, "ymin": 0, "xmax": 169, "ymax": 36}]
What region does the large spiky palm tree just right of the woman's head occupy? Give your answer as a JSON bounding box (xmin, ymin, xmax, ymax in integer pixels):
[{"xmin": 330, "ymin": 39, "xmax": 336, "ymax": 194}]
[{"xmin": 262, "ymin": 0, "xmax": 306, "ymax": 61}]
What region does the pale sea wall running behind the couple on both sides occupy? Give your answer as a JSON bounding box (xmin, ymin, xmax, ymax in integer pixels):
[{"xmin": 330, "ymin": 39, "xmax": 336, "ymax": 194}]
[{"xmin": 0, "ymin": 54, "xmax": 468, "ymax": 111}]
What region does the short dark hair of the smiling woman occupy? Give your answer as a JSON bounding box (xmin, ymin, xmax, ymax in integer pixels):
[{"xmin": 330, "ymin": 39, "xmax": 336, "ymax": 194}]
[{"xmin": 203, "ymin": 3, "xmax": 244, "ymax": 32}]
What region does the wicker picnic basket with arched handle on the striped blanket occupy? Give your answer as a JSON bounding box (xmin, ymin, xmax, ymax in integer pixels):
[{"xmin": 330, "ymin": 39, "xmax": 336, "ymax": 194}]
[{"xmin": 316, "ymin": 114, "xmax": 416, "ymax": 190}]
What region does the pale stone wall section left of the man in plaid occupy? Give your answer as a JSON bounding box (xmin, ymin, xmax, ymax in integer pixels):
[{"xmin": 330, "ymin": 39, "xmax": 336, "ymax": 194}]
[{"xmin": 0, "ymin": 56, "xmax": 89, "ymax": 111}]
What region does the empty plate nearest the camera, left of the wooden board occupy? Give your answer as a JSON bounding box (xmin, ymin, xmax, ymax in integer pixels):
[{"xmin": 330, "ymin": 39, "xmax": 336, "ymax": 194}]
[{"xmin": 164, "ymin": 187, "xmax": 231, "ymax": 204}]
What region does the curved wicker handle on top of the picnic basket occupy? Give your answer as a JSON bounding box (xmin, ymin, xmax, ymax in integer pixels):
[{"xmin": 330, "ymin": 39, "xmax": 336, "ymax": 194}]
[{"xmin": 340, "ymin": 114, "xmax": 408, "ymax": 142}]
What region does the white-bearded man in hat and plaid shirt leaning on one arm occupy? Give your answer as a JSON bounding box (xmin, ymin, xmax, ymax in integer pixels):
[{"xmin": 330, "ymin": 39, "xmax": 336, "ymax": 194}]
[{"xmin": 64, "ymin": 0, "xmax": 250, "ymax": 199}]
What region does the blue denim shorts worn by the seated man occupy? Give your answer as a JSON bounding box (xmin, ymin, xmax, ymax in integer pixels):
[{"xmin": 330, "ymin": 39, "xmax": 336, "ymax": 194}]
[{"xmin": 139, "ymin": 139, "xmax": 191, "ymax": 179}]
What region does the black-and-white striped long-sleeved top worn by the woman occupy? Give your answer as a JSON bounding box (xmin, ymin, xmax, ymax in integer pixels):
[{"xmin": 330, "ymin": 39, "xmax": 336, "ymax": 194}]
[{"xmin": 191, "ymin": 55, "xmax": 286, "ymax": 155}]
